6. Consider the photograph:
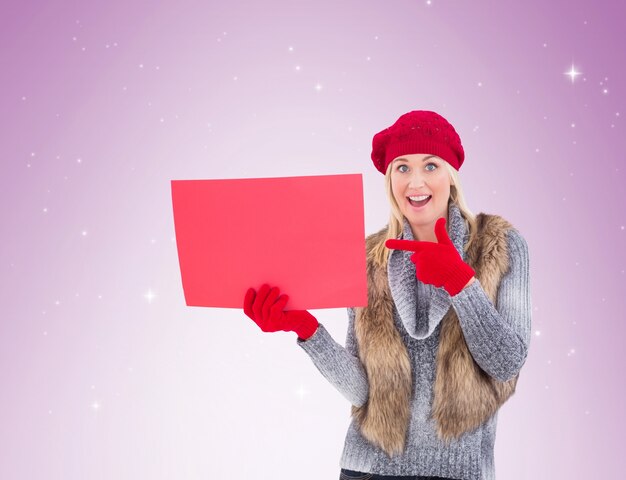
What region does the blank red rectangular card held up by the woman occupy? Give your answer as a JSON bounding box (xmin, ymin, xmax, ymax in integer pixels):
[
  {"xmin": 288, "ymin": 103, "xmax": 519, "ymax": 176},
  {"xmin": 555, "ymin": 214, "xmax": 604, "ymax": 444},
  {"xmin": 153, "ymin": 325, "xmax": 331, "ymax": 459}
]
[{"xmin": 172, "ymin": 174, "xmax": 367, "ymax": 310}]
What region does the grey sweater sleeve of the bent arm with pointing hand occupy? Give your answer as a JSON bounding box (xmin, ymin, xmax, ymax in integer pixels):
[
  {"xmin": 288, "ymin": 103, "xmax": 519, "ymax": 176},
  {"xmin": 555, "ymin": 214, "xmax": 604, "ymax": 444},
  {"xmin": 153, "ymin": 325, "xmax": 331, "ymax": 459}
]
[{"xmin": 451, "ymin": 229, "xmax": 531, "ymax": 381}]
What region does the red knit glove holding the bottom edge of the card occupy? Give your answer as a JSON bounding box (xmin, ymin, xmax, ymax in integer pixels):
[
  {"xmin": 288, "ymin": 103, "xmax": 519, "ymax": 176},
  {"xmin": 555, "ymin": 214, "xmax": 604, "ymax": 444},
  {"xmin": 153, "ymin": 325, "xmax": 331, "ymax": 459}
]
[{"xmin": 243, "ymin": 284, "xmax": 319, "ymax": 340}]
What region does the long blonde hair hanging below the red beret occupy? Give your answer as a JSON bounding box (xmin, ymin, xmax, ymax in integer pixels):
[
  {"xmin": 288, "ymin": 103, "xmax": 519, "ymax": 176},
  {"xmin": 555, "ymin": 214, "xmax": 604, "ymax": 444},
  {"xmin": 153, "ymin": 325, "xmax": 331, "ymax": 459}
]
[{"xmin": 372, "ymin": 160, "xmax": 476, "ymax": 267}]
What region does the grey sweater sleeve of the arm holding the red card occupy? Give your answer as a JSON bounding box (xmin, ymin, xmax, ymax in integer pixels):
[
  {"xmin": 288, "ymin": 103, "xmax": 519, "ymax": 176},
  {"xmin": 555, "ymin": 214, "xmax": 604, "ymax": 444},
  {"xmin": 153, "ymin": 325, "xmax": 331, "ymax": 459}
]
[{"xmin": 296, "ymin": 308, "xmax": 369, "ymax": 407}]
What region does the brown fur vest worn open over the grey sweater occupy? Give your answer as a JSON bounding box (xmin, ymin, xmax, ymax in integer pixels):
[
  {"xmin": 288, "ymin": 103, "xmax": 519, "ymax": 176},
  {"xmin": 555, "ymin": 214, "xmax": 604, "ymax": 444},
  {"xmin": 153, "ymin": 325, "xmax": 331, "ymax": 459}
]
[{"xmin": 352, "ymin": 213, "xmax": 518, "ymax": 457}]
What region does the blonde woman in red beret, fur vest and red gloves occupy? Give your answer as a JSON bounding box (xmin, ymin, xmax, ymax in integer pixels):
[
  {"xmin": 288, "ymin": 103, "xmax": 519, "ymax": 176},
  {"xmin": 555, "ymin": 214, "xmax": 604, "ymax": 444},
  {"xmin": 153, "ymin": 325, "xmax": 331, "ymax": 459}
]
[{"xmin": 244, "ymin": 110, "xmax": 531, "ymax": 480}]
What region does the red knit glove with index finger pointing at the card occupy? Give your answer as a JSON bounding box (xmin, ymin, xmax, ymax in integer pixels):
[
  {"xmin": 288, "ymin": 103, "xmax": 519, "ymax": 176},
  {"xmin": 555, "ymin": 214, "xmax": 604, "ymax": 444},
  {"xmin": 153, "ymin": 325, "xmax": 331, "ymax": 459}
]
[{"xmin": 385, "ymin": 217, "xmax": 475, "ymax": 295}]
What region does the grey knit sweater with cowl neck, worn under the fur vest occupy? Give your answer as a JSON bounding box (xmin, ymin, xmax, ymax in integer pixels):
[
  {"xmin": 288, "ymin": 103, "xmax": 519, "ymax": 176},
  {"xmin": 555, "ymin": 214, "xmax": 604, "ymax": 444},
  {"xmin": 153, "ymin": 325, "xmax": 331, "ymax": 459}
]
[{"xmin": 296, "ymin": 204, "xmax": 531, "ymax": 480}]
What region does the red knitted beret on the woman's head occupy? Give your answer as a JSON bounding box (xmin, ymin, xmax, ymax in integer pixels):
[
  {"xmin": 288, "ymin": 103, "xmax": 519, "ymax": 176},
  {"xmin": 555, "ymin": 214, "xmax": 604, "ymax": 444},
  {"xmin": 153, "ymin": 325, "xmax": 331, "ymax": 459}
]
[{"xmin": 372, "ymin": 110, "xmax": 465, "ymax": 175}]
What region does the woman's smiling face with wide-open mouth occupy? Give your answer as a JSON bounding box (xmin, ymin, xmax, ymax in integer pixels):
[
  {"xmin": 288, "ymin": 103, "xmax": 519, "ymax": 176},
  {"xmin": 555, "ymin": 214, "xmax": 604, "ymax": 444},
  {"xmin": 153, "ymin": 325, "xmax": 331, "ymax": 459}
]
[{"xmin": 390, "ymin": 153, "xmax": 450, "ymax": 242}]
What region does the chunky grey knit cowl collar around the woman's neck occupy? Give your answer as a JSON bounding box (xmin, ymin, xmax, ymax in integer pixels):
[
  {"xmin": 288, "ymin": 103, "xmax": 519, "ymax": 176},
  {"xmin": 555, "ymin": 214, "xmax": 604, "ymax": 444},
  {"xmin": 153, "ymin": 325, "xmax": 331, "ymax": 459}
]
[{"xmin": 387, "ymin": 203, "xmax": 467, "ymax": 339}]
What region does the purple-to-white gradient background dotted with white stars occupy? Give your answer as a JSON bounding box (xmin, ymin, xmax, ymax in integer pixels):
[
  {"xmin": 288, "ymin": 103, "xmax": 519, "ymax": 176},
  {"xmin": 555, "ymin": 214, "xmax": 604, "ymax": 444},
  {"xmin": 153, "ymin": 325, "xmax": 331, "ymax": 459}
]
[{"xmin": 0, "ymin": 0, "xmax": 626, "ymax": 480}]
